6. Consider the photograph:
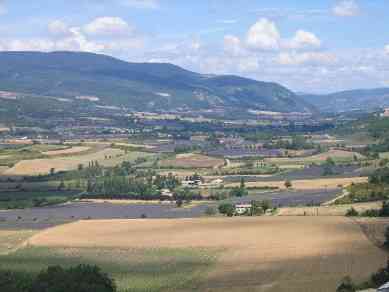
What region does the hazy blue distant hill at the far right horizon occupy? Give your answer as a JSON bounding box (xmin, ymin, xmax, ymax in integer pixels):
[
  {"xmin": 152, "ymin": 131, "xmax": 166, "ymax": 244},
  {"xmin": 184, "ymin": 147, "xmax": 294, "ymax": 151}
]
[{"xmin": 300, "ymin": 88, "xmax": 389, "ymax": 112}]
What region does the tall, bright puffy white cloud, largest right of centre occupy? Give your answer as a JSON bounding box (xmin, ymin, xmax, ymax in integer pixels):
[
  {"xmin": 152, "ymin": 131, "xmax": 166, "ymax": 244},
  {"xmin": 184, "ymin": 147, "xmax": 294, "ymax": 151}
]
[{"xmin": 246, "ymin": 18, "xmax": 281, "ymax": 50}]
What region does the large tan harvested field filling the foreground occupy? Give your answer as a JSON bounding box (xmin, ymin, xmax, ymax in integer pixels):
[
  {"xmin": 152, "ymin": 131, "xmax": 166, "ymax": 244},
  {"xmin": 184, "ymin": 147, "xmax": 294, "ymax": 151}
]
[{"xmin": 28, "ymin": 217, "xmax": 386, "ymax": 292}]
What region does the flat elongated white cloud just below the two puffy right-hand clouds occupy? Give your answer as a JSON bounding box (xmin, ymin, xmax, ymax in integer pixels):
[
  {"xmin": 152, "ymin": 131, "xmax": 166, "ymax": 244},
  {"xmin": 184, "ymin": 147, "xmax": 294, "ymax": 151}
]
[{"xmin": 276, "ymin": 52, "xmax": 336, "ymax": 65}]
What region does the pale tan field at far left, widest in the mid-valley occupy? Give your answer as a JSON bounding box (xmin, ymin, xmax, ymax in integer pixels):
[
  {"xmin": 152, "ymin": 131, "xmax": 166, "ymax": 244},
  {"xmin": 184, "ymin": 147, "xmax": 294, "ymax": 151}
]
[{"xmin": 3, "ymin": 148, "xmax": 151, "ymax": 176}]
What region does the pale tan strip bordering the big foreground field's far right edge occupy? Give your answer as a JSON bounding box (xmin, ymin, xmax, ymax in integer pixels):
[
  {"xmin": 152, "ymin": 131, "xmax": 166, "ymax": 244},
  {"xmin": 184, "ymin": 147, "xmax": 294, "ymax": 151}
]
[{"xmin": 277, "ymin": 202, "xmax": 382, "ymax": 216}]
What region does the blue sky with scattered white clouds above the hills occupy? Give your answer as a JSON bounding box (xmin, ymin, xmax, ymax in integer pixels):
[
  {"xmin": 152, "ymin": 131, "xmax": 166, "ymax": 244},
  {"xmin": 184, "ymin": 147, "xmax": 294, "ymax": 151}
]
[{"xmin": 0, "ymin": 0, "xmax": 389, "ymax": 93}]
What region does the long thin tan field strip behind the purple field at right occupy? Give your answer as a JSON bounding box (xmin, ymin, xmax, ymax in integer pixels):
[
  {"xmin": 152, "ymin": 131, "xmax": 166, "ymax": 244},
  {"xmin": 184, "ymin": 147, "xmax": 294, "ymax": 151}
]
[{"xmin": 225, "ymin": 177, "xmax": 368, "ymax": 190}]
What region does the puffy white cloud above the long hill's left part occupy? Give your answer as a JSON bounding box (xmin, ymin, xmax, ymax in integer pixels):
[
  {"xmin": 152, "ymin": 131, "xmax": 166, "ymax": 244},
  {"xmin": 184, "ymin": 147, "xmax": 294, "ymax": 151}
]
[{"xmin": 84, "ymin": 17, "xmax": 133, "ymax": 36}]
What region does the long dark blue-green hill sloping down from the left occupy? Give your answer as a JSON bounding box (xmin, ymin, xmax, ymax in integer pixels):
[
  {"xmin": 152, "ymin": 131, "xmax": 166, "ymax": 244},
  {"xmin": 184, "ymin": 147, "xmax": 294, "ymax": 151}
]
[{"xmin": 0, "ymin": 52, "xmax": 313, "ymax": 112}]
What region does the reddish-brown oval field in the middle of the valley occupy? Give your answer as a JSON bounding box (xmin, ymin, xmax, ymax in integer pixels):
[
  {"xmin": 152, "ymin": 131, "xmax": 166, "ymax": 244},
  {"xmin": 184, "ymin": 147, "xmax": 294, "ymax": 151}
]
[{"xmin": 160, "ymin": 154, "xmax": 224, "ymax": 168}]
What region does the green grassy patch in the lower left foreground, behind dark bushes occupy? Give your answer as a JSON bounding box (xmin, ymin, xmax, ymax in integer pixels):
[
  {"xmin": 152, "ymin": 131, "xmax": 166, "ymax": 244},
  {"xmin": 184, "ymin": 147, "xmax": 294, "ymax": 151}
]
[{"xmin": 0, "ymin": 247, "xmax": 215, "ymax": 292}]
